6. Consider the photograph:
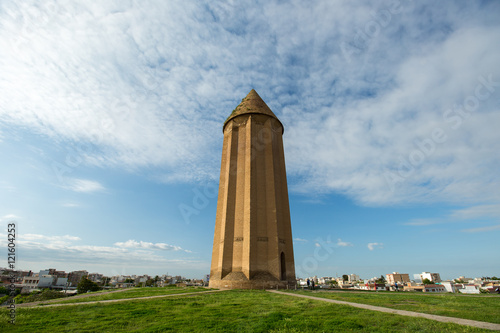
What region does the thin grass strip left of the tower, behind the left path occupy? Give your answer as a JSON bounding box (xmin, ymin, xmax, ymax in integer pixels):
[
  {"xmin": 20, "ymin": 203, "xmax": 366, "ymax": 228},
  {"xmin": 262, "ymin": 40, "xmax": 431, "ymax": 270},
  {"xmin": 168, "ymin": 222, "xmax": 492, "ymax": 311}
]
[{"xmin": 44, "ymin": 287, "xmax": 210, "ymax": 304}]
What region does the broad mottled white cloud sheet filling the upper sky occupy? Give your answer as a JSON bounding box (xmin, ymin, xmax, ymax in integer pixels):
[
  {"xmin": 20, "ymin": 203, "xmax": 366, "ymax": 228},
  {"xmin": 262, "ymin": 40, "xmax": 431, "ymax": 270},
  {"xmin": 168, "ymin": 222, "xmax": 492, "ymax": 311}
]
[{"xmin": 0, "ymin": 1, "xmax": 500, "ymax": 205}]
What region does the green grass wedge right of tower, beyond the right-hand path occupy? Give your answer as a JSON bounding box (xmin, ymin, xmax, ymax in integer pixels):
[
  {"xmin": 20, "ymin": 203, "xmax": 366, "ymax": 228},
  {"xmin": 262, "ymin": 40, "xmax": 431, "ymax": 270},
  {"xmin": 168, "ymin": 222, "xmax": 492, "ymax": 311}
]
[{"xmin": 286, "ymin": 291, "xmax": 500, "ymax": 324}]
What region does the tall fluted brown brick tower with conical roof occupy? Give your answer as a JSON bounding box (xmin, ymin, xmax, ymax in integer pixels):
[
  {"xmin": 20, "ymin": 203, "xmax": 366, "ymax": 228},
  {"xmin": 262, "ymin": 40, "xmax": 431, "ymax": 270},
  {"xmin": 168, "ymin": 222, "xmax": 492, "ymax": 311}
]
[{"xmin": 209, "ymin": 89, "xmax": 296, "ymax": 289}]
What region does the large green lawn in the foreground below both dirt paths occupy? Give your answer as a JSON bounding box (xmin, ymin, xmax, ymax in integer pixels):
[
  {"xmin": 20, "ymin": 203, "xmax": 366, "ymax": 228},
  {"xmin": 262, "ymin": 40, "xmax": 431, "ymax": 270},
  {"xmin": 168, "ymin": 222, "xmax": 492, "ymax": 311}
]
[{"xmin": 0, "ymin": 290, "xmax": 492, "ymax": 332}]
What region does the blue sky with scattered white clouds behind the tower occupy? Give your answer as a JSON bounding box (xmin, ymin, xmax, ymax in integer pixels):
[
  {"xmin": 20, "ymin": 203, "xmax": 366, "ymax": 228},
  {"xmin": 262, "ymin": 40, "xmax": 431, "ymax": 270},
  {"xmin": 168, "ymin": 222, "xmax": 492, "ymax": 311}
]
[{"xmin": 0, "ymin": 0, "xmax": 500, "ymax": 278}]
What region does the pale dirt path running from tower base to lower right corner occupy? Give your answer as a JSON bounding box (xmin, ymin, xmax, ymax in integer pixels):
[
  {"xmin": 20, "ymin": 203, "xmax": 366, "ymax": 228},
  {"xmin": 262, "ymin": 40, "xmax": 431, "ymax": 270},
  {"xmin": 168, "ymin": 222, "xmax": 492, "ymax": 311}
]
[{"xmin": 268, "ymin": 290, "xmax": 500, "ymax": 331}]
